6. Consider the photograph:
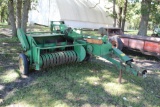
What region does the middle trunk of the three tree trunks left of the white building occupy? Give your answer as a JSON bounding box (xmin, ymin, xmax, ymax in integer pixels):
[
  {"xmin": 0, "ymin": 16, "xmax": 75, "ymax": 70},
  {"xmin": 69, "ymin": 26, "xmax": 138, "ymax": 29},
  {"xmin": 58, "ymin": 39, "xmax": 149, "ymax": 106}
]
[{"xmin": 16, "ymin": 0, "xmax": 22, "ymax": 28}]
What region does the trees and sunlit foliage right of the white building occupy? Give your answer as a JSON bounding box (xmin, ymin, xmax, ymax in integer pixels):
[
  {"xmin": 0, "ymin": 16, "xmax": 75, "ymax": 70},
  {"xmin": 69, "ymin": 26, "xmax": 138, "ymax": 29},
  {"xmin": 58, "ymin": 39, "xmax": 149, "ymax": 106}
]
[{"xmin": 110, "ymin": 0, "xmax": 160, "ymax": 36}]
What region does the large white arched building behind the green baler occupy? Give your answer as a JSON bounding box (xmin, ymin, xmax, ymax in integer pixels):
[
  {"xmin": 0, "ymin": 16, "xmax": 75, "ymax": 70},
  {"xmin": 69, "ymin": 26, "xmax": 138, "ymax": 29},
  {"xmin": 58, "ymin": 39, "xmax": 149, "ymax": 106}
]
[{"xmin": 29, "ymin": 0, "xmax": 113, "ymax": 28}]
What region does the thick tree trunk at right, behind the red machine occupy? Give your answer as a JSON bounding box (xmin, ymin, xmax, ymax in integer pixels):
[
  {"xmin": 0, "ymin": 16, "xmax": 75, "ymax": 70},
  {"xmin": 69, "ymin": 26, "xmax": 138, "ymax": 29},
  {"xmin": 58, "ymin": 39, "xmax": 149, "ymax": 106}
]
[{"xmin": 138, "ymin": 0, "xmax": 152, "ymax": 36}]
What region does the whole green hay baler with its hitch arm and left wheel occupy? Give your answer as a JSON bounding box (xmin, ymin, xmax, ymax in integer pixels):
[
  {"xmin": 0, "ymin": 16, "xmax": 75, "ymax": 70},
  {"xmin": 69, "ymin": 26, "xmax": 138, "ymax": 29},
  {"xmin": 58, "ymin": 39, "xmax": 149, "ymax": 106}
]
[{"xmin": 17, "ymin": 21, "xmax": 146, "ymax": 75}]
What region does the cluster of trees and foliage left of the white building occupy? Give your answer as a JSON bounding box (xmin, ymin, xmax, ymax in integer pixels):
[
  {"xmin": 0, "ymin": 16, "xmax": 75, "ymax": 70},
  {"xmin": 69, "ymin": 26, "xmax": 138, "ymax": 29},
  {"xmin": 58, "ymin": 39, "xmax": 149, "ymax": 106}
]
[{"xmin": 0, "ymin": 0, "xmax": 33, "ymax": 36}]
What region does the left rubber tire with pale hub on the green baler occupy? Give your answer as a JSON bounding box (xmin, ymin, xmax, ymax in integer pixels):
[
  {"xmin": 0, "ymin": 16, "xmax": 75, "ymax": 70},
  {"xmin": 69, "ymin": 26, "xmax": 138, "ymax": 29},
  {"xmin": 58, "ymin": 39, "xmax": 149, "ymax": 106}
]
[{"xmin": 19, "ymin": 53, "xmax": 29, "ymax": 75}]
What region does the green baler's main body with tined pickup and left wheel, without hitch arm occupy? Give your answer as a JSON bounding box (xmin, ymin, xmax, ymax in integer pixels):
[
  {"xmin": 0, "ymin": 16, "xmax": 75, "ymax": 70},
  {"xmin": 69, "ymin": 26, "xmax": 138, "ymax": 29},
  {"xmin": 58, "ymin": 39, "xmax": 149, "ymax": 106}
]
[{"xmin": 17, "ymin": 22, "xmax": 86, "ymax": 74}]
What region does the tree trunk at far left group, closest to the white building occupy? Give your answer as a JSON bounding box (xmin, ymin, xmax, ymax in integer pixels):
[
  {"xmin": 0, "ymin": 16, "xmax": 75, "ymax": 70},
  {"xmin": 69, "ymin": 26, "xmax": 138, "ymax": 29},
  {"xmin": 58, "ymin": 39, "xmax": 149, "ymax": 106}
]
[{"xmin": 21, "ymin": 0, "xmax": 31, "ymax": 32}]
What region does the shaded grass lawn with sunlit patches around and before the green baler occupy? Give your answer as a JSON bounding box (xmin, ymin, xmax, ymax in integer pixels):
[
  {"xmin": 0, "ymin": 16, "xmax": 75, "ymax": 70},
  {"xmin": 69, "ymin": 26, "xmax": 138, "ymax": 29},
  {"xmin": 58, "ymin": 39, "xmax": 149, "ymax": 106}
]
[{"xmin": 0, "ymin": 26, "xmax": 160, "ymax": 107}]
